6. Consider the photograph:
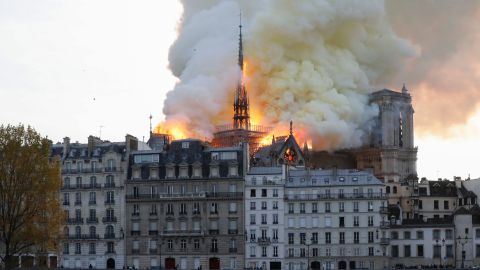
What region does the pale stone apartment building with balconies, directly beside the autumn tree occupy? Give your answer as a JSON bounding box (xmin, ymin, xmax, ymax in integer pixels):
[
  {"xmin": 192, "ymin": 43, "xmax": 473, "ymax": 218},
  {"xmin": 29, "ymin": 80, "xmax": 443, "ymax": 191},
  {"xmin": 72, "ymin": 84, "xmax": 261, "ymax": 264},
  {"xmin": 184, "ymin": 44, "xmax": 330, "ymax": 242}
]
[{"xmin": 52, "ymin": 135, "xmax": 138, "ymax": 269}]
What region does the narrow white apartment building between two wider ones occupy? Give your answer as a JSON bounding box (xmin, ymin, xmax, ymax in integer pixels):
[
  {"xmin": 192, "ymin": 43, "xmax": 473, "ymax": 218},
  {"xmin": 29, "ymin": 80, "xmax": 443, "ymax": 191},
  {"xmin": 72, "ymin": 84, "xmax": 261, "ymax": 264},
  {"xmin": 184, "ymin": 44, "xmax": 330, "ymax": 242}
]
[{"xmin": 244, "ymin": 166, "xmax": 286, "ymax": 270}]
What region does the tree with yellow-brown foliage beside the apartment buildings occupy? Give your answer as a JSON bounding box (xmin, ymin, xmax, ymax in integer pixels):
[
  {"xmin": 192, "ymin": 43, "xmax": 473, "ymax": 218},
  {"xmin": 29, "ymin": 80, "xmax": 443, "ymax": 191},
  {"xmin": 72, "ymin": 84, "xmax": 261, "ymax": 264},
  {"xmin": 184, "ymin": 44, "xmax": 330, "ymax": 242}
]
[{"xmin": 0, "ymin": 125, "xmax": 64, "ymax": 269}]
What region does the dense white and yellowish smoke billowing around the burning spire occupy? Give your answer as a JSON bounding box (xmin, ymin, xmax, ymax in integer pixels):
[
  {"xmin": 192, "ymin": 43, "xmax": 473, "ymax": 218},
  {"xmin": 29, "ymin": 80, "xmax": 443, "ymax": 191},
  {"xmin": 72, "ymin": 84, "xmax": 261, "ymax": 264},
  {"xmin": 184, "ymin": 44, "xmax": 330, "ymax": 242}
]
[{"xmin": 164, "ymin": 0, "xmax": 415, "ymax": 148}]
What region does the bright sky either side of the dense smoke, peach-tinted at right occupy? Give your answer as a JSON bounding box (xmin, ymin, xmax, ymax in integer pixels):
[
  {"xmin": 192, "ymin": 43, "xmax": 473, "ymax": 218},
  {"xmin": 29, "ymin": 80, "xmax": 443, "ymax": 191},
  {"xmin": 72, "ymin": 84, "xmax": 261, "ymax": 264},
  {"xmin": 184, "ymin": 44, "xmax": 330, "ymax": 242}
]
[{"xmin": 0, "ymin": 0, "xmax": 480, "ymax": 179}]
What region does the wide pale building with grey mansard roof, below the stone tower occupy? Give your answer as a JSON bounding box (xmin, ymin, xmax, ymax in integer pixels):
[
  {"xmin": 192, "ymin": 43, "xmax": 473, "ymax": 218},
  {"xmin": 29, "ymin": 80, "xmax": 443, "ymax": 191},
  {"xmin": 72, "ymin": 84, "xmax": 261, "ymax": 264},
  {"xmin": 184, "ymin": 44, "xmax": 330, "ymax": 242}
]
[{"xmin": 285, "ymin": 168, "xmax": 389, "ymax": 270}]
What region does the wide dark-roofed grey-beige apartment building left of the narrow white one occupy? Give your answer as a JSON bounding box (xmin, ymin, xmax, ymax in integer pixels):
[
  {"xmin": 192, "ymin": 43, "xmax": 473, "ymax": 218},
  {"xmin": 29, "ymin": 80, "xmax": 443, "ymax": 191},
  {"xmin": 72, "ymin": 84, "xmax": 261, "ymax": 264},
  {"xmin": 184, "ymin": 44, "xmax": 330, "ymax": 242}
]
[{"xmin": 126, "ymin": 139, "xmax": 247, "ymax": 269}]
